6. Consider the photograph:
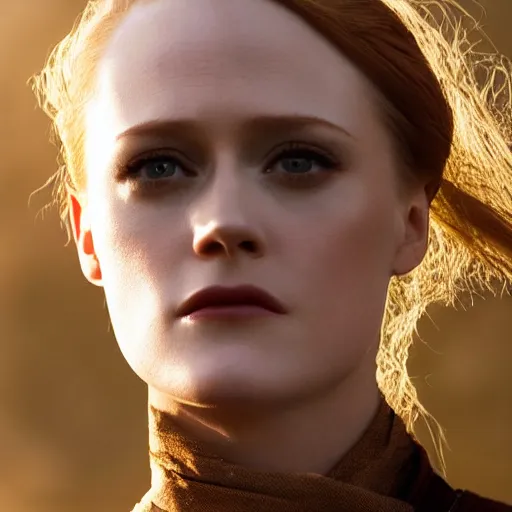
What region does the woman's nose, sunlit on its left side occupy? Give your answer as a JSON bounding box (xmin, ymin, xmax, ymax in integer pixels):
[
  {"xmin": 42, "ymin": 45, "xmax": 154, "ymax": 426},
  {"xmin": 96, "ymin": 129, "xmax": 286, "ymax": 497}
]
[{"xmin": 192, "ymin": 174, "xmax": 265, "ymax": 258}]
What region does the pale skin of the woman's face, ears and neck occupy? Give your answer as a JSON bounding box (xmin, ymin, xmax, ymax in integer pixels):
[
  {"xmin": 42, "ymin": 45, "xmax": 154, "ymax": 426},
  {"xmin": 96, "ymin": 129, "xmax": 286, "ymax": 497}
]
[{"xmin": 70, "ymin": 0, "xmax": 428, "ymax": 473}]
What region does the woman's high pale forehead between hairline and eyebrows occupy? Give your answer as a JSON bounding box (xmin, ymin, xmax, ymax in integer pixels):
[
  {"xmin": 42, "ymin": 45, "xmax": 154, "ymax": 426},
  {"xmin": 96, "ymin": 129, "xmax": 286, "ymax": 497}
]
[{"xmin": 91, "ymin": 0, "xmax": 373, "ymax": 141}]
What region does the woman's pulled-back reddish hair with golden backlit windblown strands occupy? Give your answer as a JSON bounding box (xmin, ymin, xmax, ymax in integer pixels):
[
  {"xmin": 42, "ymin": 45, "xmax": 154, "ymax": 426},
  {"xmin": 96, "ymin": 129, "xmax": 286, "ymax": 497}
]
[{"xmin": 32, "ymin": 0, "xmax": 512, "ymax": 469}]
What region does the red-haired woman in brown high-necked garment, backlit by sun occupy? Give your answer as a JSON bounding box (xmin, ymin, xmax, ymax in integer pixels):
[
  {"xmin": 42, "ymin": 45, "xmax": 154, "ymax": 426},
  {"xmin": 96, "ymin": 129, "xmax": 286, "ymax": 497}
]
[{"xmin": 31, "ymin": 0, "xmax": 512, "ymax": 512}]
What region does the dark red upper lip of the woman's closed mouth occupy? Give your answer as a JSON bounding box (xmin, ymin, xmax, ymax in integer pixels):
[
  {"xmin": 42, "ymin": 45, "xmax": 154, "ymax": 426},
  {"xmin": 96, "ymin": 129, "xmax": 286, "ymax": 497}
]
[{"xmin": 176, "ymin": 285, "xmax": 286, "ymax": 317}]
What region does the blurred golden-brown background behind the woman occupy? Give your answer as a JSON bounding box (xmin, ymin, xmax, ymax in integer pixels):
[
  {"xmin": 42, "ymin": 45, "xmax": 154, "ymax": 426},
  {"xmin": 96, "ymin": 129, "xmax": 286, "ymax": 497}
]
[{"xmin": 0, "ymin": 0, "xmax": 512, "ymax": 512}]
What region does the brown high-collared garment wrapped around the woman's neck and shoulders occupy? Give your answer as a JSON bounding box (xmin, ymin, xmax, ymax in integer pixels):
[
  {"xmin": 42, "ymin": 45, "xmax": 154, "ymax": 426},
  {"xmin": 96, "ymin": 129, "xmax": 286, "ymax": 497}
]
[{"xmin": 133, "ymin": 401, "xmax": 512, "ymax": 512}]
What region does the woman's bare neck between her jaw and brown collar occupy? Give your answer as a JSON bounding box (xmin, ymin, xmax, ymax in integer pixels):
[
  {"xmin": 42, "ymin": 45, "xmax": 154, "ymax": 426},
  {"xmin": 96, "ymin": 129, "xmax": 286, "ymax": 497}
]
[{"xmin": 149, "ymin": 358, "xmax": 381, "ymax": 474}]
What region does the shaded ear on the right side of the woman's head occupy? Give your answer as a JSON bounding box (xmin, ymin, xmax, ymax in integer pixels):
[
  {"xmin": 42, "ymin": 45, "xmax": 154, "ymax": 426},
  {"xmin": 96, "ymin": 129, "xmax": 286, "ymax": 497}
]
[{"xmin": 393, "ymin": 187, "xmax": 430, "ymax": 276}]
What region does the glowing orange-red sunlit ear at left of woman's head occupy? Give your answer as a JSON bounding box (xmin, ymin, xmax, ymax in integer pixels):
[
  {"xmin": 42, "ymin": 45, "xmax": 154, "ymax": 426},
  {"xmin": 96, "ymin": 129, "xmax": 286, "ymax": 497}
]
[{"xmin": 68, "ymin": 190, "xmax": 102, "ymax": 286}]
